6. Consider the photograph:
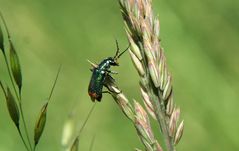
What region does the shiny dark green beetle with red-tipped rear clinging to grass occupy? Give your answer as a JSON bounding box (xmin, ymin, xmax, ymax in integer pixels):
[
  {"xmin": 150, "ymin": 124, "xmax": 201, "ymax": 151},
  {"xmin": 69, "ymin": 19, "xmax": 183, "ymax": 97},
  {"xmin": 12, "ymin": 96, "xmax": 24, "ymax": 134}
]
[{"xmin": 88, "ymin": 40, "xmax": 129, "ymax": 102}]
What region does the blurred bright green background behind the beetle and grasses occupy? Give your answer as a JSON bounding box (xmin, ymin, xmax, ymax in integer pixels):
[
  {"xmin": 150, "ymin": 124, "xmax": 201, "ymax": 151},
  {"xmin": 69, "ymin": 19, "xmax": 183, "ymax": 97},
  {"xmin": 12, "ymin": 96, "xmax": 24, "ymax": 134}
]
[{"xmin": 0, "ymin": 0, "xmax": 239, "ymax": 151}]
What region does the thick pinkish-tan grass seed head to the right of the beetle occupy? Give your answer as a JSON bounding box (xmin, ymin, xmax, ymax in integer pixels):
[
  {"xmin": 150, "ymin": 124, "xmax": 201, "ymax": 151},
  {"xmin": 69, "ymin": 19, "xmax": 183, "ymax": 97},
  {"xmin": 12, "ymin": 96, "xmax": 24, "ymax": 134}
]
[{"xmin": 119, "ymin": 0, "xmax": 183, "ymax": 151}]
